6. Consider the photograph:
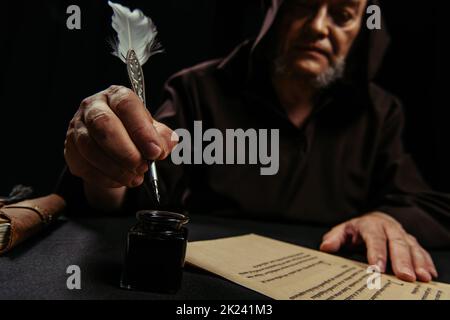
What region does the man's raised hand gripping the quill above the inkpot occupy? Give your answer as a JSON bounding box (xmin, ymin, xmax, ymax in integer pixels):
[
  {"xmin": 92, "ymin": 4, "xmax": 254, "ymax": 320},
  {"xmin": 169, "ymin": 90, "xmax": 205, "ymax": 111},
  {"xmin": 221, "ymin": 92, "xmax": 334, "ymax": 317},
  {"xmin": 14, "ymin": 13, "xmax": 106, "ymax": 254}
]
[{"xmin": 64, "ymin": 86, "xmax": 177, "ymax": 207}]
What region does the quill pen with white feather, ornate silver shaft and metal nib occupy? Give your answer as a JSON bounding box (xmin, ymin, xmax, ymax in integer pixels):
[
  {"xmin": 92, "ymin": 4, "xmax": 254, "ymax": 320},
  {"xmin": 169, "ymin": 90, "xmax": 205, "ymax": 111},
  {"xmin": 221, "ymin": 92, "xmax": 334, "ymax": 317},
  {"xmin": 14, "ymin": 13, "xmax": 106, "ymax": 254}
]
[{"xmin": 108, "ymin": 1, "xmax": 163, "ymax": 204}]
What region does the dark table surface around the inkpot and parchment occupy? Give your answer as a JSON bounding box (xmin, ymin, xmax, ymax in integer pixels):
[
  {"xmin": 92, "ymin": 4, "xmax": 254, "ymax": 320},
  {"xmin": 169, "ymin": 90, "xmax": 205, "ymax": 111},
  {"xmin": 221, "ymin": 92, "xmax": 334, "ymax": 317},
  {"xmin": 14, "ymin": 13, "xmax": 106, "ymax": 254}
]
[{"xmin": 0, "ymin": 216, "xmax": 450, "ymax": 300}]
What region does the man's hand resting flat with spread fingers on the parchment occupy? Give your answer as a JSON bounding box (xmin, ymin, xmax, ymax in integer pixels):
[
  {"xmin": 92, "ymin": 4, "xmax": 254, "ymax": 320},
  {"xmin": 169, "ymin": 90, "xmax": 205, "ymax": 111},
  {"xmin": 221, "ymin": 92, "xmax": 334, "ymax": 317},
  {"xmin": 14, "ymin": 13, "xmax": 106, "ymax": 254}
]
[{"xmin": 320, "ymin": 212, "xmax": 438, "ymax": 282}]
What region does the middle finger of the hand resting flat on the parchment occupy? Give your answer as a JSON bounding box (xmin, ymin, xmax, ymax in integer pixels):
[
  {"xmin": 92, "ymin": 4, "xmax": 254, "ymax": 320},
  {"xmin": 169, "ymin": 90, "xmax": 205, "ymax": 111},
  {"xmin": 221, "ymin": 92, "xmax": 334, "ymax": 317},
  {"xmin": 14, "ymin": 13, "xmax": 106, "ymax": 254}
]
[{"xmin": 385, "ymin": 224, "xmax": 416, "ymax": 282}]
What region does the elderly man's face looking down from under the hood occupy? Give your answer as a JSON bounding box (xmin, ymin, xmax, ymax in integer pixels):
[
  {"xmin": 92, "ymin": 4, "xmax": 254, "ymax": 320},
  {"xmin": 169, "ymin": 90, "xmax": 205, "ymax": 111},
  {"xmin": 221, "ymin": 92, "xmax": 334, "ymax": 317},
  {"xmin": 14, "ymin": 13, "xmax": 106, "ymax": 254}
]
[{"xmin": 276, "ymin": 0, "xmax": 367, "ymax": 84}]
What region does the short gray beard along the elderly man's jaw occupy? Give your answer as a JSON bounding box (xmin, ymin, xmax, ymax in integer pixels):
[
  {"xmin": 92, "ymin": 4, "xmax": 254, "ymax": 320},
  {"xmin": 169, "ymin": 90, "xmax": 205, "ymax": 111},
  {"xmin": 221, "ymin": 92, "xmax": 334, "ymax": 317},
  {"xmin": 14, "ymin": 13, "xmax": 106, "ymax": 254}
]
[{"xmin": 274, "ymin": 57, "xmax": 345, "ymax": 89}]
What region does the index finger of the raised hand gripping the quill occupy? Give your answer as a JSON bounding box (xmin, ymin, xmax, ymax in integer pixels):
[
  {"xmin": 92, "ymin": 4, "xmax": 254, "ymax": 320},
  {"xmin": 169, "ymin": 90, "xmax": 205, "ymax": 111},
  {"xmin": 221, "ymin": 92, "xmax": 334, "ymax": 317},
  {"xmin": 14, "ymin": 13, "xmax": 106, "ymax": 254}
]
[{"xmin": 104, "ymin": 86, "xmax": 178, "ymax": 160}]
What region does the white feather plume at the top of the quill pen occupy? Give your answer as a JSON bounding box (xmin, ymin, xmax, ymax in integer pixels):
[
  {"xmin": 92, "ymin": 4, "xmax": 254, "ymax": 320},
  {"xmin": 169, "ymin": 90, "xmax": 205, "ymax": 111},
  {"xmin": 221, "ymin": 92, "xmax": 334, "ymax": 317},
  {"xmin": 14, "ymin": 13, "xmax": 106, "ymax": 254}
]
[{"xmin": 108, "ymin": 1, "xmax": 163, "ymax": 65}]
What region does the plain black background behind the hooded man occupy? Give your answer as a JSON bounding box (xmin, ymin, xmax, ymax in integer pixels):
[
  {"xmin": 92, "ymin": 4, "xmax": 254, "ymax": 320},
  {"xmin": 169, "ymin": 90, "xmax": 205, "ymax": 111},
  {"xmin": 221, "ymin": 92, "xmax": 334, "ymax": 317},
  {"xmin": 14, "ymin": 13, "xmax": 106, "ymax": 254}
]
[{"xmin": 0, "ymin": 0, "xmax": 450, "ymax": 194}]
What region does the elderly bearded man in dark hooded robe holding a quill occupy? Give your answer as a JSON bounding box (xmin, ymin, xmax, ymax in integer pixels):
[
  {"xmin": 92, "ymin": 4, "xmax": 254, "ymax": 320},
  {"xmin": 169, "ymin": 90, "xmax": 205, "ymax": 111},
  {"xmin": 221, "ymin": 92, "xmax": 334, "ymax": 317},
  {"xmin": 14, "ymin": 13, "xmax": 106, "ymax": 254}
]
[{"xmin": 62, "ymin": 0, "xmax": 450, "ymax": 282}]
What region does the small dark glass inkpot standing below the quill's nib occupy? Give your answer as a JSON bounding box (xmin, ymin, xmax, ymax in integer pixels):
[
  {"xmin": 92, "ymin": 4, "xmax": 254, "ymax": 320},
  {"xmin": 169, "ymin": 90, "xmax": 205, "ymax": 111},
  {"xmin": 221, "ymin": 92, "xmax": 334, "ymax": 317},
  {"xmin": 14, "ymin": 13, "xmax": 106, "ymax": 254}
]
[{"xmin": 120, "ymin": 210, "xmax": 189, "ymax": 294}]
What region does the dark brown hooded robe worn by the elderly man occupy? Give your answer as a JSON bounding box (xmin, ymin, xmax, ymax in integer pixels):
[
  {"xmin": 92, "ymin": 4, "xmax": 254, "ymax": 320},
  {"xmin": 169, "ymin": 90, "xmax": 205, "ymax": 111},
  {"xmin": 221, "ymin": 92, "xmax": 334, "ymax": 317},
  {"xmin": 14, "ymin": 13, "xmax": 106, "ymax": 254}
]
[{"xmin": 56, "ymin": 0, "xmax": 450, "ymax": 246}]
